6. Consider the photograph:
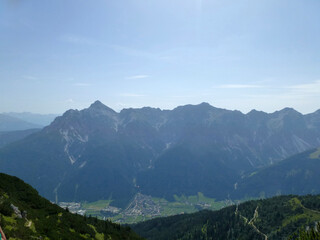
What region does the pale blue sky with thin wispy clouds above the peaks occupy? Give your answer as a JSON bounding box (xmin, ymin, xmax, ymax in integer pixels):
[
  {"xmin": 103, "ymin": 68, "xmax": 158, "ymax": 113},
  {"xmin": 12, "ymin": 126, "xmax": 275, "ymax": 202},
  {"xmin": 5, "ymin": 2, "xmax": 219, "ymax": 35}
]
[{"xmin": 0, "ymin": 0, "xmax": 320, "ymax": 113}]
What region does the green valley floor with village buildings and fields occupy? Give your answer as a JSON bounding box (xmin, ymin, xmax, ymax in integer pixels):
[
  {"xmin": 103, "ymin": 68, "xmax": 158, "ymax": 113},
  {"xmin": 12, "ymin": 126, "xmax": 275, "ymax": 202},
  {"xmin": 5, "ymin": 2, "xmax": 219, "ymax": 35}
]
[{"xmin": 59, "ymin": 193, "xmax": 235, "ymax": 224}]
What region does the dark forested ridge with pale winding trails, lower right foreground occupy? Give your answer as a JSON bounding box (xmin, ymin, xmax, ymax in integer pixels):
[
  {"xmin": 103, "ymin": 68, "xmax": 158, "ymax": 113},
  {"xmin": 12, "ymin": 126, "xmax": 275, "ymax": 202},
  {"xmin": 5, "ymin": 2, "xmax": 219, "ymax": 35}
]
[{"xmin": 132, "ymin": 195, "xmax": 320, "ymax": 240}]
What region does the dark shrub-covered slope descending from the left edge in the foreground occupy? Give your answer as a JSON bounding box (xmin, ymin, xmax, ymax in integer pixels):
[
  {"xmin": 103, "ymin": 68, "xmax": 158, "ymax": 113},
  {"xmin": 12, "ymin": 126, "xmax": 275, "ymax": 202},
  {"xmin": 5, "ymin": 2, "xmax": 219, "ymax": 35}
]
[{"xmin": 0, "ymin": 173, "xmax": 142, "ymax": 240}]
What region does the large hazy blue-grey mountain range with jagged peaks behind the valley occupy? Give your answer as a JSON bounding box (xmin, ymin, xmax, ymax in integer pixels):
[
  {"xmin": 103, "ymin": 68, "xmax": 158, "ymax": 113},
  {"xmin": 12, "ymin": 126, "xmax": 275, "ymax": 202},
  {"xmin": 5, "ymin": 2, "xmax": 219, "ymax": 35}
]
[{"xmin": 0, "ymin": 101, "xmax": 320, "ymax": 208}]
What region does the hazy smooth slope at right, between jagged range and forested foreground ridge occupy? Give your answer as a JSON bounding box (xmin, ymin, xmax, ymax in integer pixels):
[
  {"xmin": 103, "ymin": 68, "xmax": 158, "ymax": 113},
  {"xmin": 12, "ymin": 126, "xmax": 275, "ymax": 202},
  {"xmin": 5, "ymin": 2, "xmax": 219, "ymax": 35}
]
[{"xmin": 232, "ymin": 148, "xmax": 320, "ymax": 199}]
